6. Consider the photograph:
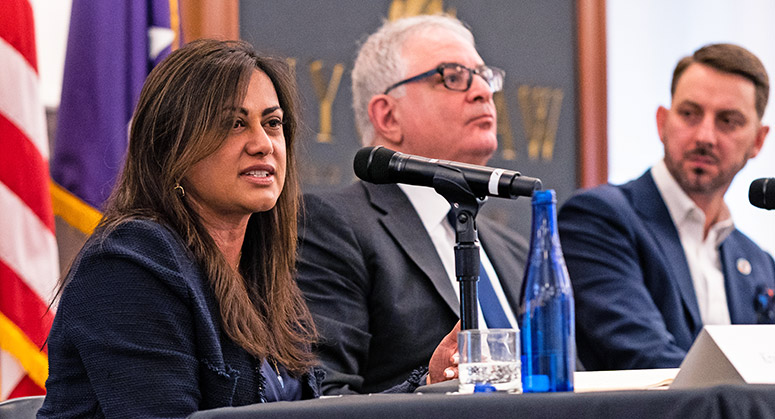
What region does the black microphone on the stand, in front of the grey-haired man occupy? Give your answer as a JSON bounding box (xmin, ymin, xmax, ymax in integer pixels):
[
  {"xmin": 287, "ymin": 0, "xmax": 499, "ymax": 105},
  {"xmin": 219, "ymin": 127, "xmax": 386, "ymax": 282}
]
[{"xmin": 353, "ymin": 146, "xmax": 541, "ymax": 198}]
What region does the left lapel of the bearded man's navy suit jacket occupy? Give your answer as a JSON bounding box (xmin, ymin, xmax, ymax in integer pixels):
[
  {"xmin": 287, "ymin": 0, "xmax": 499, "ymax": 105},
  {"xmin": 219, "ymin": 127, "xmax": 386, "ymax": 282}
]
[{"xmin": 624, "ymin": 171, "xmax": 702, "ymax": 335}]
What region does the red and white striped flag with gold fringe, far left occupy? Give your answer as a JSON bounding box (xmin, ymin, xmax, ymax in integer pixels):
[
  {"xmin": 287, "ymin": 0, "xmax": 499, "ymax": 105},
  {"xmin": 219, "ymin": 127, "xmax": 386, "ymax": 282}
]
[{"xmin": 0, "ymin": 0, "xmax": 59, "ymax": 400}]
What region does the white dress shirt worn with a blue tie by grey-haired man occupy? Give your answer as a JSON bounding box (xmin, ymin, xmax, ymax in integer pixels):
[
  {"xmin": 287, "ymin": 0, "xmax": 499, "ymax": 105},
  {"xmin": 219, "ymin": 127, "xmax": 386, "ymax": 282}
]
[{"xmin": 398, "ymin": 184, "xmax": 521, "ymax": 329}]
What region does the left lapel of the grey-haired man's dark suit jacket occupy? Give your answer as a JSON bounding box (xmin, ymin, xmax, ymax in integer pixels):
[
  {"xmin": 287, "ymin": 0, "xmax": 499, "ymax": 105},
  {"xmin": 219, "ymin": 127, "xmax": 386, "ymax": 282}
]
[{"xmin": 362, "ymin": 182, "xmax": 460, "ymax": 316}]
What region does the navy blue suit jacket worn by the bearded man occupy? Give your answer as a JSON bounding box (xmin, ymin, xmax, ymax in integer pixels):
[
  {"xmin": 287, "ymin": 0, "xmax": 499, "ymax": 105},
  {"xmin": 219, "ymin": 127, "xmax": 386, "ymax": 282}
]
[{"xmin": 559, "ymin": 171, "xmax": 775, "ymax": 370}]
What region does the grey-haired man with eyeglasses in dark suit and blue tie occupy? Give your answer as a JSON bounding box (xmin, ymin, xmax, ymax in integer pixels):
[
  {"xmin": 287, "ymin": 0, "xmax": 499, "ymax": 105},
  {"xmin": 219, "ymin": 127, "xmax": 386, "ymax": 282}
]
[{"xmin": 297, "ymin": 16, "xmax": 527, "ymax": 394}]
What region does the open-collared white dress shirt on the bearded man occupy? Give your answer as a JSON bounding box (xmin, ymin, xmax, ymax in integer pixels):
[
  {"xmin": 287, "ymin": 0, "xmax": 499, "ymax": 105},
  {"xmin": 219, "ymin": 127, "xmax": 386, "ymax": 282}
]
[{"xmin": 651, "ymin": 160, "xmax": 735, "ymax": 324}]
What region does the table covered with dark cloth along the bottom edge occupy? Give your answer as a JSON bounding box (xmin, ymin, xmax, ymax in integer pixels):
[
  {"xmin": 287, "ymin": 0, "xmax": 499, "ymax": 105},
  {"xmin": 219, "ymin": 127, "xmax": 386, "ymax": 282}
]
[{"xmin": 191, "ymin": 385, "xmax": 775, "ymax": 419}]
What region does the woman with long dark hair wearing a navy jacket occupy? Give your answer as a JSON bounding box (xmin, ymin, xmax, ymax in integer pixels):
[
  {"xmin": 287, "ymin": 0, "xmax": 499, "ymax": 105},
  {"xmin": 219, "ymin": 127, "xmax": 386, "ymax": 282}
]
[{"xmin": 39, "ymin": 41, "xmax": 318, "ymax": 417}]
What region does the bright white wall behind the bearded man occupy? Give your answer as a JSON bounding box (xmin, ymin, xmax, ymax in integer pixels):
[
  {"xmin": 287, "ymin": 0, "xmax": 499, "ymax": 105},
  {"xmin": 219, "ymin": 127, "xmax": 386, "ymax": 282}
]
[{"xmin": 607, "ymin": 0, "xmax": 775, "ymax": 254}]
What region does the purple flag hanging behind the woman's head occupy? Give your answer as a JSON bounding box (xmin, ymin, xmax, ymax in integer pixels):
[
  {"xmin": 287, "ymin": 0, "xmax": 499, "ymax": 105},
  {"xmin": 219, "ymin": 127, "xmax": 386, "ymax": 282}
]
[{"xmin": 51, "ymin": 0, "xmax": 179, "ymax": 209}]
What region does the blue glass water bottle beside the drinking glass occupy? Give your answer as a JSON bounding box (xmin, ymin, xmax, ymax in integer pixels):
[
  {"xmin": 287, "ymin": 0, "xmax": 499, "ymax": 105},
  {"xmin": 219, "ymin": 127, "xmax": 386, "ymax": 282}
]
[{"xmin": 519, "ymin": 189, "xmax": 576, "ymax": 393}]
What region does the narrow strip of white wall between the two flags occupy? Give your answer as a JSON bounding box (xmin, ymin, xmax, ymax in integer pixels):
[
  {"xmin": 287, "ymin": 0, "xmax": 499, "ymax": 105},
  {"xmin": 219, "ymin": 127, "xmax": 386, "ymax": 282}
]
[{"xmin": 30, "ymin": 0, "xmax": 71, "ymax": 107}]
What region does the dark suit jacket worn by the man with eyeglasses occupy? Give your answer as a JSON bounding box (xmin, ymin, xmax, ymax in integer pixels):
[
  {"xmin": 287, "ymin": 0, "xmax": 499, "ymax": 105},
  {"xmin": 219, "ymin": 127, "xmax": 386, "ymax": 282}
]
[{"xmin": 297, "ymin": 182, "xmax": 527, "ymax": 394}]
